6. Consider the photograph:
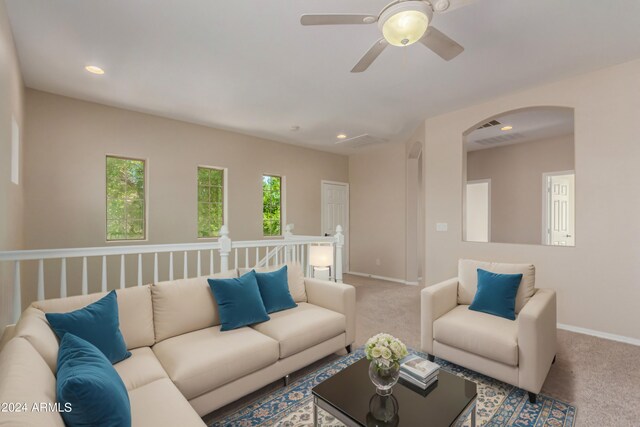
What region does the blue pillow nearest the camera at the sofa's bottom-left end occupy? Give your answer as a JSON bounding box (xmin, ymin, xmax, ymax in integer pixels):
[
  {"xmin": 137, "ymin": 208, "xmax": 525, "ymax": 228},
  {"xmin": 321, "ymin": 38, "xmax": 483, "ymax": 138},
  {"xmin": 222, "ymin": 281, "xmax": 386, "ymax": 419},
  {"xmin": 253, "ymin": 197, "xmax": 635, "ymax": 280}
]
[{"xmin": 56, "ymin": 332, "xmax": 131, "ymax": 427}]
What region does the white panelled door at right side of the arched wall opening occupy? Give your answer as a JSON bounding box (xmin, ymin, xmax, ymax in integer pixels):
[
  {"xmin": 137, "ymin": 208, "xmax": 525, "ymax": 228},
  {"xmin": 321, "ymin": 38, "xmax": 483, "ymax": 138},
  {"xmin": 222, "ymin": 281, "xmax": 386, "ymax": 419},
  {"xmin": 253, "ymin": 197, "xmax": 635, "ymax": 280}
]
[{"xmin": 545, "ymin": 173, "xmax": 575, "ymax": 246}]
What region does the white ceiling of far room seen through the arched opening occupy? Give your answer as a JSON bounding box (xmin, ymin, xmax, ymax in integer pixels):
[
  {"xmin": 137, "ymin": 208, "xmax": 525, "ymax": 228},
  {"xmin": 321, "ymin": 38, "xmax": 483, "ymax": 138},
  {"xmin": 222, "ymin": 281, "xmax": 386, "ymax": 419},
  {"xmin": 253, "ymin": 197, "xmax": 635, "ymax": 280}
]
[{"xmin": 464, "ymin": 107, "xmax": 574, "ymax": 151}]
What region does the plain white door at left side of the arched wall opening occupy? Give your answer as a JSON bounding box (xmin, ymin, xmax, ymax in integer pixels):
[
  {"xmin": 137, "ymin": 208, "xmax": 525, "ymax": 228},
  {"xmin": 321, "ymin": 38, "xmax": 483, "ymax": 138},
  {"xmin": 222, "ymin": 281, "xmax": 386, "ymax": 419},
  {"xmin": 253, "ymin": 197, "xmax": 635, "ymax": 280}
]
[{"xmin": 465, "ymin": 179, "xmax": 491, "ymax": 242}]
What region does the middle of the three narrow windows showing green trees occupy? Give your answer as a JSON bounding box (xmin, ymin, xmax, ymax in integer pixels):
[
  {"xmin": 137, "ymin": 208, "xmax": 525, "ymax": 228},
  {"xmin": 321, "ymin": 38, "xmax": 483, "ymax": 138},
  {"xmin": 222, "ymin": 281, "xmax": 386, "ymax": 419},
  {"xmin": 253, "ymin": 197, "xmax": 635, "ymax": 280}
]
[{"xmin": 198, "ymin": 166, "xmax": 225, "ymax": 238}]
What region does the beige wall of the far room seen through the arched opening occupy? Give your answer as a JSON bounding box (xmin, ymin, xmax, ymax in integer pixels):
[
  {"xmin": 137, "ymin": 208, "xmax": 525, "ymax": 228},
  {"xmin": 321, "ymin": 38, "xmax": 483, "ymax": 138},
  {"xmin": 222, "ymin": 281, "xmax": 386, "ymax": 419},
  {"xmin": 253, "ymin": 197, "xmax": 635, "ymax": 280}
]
[{"xmin": 467, "ymin": 135, "xmax": 574, "ymax": 244}]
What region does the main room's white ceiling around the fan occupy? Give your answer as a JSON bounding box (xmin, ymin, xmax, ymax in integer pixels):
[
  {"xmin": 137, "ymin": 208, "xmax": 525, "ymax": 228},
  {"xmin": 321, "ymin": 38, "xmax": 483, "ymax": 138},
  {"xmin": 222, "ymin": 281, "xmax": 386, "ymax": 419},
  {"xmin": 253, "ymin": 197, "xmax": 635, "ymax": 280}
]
[{"xmin": 0, "ymin": 0, "xmax": 640, "ymax": 153}]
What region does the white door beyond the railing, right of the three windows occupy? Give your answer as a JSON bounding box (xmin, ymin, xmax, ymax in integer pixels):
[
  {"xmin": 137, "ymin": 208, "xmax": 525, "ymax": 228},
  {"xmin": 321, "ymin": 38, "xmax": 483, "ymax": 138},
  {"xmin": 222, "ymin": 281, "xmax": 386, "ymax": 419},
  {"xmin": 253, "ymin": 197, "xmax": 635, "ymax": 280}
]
[{"xmin": 321, "ymin": 181, "xmax": 349, "ymax": 272}]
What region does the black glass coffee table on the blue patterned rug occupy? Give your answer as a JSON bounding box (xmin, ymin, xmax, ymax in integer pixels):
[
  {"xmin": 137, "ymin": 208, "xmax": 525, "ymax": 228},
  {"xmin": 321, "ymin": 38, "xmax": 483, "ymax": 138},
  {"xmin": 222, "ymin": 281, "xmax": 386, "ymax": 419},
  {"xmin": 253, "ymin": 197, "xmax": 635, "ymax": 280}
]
[{"xmin": 312, "ymin": 359, "xmax": 477, "ymax": 427}]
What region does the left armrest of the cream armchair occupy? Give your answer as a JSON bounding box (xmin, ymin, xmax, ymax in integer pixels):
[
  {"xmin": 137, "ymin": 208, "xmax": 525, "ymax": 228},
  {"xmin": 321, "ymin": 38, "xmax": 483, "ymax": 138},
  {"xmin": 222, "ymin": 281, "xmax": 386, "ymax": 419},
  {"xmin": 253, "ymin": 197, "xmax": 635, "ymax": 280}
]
[{"xmin": 420, "ymin": 277, "xmax": 458, "ymax": 354}]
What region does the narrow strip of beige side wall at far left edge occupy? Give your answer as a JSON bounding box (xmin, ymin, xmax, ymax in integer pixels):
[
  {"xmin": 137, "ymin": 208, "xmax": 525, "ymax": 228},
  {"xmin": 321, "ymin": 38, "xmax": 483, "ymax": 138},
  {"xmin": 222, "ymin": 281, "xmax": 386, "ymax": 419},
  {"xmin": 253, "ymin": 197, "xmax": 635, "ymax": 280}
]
[{"xmin": 0, "ymin": 2, "xmax": 24, "ymax": 334}]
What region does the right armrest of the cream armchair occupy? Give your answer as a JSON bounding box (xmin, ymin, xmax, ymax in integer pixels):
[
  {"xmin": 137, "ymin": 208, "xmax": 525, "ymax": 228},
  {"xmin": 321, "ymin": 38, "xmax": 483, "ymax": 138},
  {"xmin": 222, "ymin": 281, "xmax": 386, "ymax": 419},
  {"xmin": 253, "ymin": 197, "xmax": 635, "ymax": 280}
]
[{"xmin": 518, "ymin": 289, "xmax": 557, "ymax": 393}]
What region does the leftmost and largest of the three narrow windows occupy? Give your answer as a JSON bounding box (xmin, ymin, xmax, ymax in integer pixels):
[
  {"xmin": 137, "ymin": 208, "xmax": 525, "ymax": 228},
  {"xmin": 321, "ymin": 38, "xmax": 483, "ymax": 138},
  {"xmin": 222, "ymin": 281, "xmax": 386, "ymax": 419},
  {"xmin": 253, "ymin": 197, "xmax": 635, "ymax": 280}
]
[{"xmin": 107, "ymin": 156, "xmax": 146, "ymax": 240}]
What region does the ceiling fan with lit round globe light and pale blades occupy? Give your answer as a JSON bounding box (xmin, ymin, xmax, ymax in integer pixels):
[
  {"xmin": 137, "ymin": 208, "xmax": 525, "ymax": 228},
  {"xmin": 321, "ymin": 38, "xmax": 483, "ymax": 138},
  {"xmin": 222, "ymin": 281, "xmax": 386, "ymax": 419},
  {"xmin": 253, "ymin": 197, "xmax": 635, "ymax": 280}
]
[{"xmin": 300, "ymin": 0, "xmax": 475, "ymax": 73}]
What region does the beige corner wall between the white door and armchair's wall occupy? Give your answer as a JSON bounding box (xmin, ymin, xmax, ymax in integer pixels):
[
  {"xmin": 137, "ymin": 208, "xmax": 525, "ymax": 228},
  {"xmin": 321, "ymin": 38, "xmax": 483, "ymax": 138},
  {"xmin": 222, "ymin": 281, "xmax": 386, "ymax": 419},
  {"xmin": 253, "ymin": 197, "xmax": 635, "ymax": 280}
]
[{"xmin": 349, "ymin": 125, "xmax": 424, "ymax": 284}]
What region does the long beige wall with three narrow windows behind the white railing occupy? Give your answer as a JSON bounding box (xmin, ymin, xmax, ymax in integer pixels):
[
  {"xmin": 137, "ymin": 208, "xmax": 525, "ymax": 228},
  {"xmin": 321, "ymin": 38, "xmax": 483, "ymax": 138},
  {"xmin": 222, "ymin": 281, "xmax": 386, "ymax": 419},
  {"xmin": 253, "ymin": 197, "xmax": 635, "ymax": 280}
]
[{"xmin": 24, "ymin": 89, "xmax": 348, "ymax": 303}]
